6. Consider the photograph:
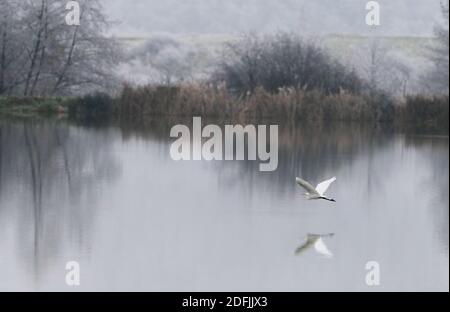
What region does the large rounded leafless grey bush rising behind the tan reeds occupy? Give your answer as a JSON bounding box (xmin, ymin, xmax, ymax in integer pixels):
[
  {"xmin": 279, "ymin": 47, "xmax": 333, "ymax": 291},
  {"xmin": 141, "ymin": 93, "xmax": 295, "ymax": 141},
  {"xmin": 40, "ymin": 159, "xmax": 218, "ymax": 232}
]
[{"xmin": 214, "ymin": 33, "xmax": 363, "ymax": 94}]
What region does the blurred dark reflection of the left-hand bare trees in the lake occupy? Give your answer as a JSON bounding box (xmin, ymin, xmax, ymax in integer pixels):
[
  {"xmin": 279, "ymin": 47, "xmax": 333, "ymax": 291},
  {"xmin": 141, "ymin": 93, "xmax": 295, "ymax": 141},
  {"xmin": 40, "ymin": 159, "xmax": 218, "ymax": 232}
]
[{"xmin": 0, "ymin": 121, "xmax": 120, "ymax": 281}]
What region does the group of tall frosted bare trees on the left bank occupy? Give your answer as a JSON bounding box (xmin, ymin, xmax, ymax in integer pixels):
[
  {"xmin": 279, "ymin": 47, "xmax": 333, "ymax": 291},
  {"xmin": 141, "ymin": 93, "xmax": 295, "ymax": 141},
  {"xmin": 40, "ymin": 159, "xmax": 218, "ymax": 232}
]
[{"xmin": 0, "ymin": 0, "xmax": 120, "ymax": 96}]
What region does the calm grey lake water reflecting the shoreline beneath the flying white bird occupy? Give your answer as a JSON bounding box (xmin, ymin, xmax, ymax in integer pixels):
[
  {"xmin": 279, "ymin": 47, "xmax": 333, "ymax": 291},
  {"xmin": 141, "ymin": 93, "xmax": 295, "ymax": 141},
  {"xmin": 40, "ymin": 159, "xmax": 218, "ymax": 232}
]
[{"xmin": 0, "ymin": 120, "xmax": 449, "ymax": 291}]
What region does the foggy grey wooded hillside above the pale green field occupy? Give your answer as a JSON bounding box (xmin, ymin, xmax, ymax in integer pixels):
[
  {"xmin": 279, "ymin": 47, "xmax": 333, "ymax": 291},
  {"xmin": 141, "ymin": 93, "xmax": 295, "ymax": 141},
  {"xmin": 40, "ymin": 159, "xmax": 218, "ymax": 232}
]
[{"xmin": 102, "ymin": 0, "xmax": 442, "ymax": 36}]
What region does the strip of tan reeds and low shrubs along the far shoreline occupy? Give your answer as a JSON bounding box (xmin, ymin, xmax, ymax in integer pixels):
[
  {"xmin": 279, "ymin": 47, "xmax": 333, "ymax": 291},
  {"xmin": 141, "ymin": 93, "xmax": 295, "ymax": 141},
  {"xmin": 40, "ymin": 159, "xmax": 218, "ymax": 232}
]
[{"xmin": 0, "ymin": 84, "xmax": 449, "ymax": 133}]
